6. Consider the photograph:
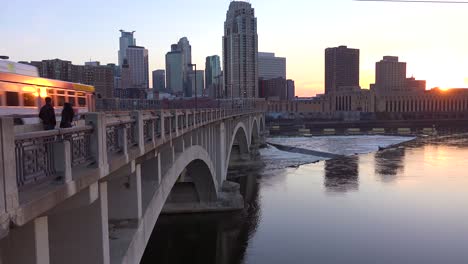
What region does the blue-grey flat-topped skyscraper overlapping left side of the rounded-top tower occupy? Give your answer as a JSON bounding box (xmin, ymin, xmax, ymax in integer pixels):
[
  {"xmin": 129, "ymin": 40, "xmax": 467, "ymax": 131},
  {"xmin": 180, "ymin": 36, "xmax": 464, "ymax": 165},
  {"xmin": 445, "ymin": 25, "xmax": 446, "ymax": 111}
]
[{"xmin": 166, "ymin": 50, "xmax": 184, "ymax": 96}]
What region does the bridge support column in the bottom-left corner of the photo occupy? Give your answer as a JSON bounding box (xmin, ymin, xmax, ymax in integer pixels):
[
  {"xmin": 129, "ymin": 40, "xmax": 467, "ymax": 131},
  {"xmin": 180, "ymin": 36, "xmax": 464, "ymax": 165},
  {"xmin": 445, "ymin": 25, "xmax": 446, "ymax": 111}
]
[{"xmin": 0, "ymin": 216, "xmax": 50, "ymax": 264}]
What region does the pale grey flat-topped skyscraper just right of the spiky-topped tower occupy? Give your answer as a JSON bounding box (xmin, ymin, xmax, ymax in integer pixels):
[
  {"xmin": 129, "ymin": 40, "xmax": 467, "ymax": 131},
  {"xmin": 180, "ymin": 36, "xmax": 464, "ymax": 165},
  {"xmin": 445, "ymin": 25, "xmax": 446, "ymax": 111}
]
[{"xmin": 126, "ymin": 46, "xmax": 149, "ymax": 89}]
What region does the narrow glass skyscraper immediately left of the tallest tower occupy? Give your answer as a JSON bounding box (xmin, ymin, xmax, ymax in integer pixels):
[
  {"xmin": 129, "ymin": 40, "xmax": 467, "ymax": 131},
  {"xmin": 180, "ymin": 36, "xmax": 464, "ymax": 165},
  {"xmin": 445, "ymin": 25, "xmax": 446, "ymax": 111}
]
[{"xmin": 205, "ymin": 55, "xmax": 222, "ymax": 98}]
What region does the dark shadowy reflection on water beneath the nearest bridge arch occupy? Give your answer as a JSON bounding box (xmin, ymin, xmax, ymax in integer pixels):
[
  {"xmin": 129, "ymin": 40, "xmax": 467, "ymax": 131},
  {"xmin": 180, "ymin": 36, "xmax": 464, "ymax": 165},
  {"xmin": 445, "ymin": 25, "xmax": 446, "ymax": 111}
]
[{"xmin": 141, "ymin": 173, "xmax": 260, "ymax": 264}]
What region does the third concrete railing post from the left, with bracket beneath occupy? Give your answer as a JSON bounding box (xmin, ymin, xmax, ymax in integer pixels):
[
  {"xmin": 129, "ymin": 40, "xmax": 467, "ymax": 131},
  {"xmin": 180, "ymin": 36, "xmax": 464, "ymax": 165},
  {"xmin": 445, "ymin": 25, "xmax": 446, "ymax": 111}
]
[{"xmin": 85, "ymin": 113, "xmax": 109, "ymax": 178}]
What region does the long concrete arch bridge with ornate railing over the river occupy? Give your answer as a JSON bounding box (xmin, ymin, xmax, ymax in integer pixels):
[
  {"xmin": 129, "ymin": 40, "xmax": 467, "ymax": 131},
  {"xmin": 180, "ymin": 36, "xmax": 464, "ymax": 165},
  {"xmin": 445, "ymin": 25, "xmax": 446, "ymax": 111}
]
[{"xmin": 0, "ymin": 108, "xmax": 265, "ymax": 264}]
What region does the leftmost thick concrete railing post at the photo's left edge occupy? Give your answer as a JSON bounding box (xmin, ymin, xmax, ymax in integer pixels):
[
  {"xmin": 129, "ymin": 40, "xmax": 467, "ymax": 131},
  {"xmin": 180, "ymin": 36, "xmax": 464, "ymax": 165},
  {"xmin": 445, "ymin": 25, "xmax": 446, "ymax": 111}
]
[{"xmin": 0, "ymin": 117, "xmax": 19, "ymax": 214}]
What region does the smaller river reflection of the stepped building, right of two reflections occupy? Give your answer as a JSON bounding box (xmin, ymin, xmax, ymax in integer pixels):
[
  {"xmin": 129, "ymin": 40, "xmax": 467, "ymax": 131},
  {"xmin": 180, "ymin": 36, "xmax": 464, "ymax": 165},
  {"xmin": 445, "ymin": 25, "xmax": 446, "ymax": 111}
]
[{"xmin": 374, "ymin": 148, "xmax": 405, "ymax": 182}]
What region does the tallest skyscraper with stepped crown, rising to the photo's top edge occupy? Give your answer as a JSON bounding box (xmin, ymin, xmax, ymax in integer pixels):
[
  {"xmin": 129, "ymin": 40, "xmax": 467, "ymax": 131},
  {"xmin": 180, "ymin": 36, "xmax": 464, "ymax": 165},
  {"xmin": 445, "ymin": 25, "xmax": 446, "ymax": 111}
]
[{"xmin": 223, "ymin": 1, "xmax": 258, "ymax": 98}]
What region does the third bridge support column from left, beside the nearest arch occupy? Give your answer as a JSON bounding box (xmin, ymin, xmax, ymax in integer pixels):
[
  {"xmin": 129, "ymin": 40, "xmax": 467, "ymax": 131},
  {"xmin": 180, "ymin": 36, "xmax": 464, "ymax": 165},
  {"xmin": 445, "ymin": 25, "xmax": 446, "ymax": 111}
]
[{"xmin": 107, "ymin": 164, "xmax": 142, "ymax": 221}]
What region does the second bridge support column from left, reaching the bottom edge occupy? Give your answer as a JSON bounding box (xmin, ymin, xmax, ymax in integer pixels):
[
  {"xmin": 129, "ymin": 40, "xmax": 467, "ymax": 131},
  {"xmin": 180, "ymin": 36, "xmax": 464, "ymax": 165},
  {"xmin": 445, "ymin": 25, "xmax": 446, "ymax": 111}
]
[{"xmin": 48, "ymin": 182, "xmax": 110, "ymax": 264}]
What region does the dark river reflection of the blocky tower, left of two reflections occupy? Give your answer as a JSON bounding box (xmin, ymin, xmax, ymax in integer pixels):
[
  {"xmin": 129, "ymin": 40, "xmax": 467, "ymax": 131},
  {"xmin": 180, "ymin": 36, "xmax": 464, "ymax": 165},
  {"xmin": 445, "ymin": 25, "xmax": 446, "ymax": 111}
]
[{"xmin": 324, "ymin": 156, "xmax": 359, "ymax": 192}]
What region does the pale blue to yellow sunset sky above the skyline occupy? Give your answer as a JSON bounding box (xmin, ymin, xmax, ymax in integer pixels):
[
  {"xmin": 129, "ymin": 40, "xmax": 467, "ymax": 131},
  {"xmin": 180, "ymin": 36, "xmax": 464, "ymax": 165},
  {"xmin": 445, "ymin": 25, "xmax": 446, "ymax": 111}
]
[{"xmin": 0, "ymin": 0, "xmax": 468, "ymax": 96}]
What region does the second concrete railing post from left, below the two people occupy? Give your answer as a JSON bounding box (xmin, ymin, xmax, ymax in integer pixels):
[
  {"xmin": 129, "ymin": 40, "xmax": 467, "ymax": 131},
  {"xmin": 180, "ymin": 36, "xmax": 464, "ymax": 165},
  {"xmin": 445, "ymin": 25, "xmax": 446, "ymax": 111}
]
[{"xmin": 52, "ymin": 140, "xmax": 72, "ymax": 182}]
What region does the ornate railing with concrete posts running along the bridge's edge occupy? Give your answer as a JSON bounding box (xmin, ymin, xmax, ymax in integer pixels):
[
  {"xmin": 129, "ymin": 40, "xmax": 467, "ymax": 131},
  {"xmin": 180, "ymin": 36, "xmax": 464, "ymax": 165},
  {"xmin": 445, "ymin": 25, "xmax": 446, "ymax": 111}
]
[{"xmin": 0, "ymin": 100, "xmax": 264, "ymax": 221}]
